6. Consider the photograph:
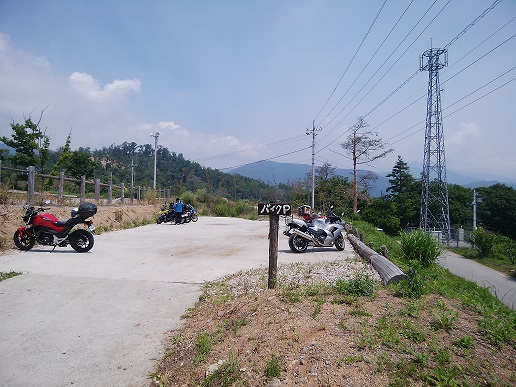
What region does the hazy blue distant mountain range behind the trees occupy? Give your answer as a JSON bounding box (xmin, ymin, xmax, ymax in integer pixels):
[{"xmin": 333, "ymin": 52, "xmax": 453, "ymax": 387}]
[{"xmin": 230, "ymin": 161, "xmax": 516, "ymax": 197}]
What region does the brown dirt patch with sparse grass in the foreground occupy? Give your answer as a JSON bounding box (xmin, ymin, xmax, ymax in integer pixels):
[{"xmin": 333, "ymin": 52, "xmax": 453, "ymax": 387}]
[{"xmin": 151, "ymin": 263, "xmax": 516, "ymax": 386}]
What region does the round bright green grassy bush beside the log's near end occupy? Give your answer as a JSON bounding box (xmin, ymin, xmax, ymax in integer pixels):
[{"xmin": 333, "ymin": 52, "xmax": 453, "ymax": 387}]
[{"xmin": 401, "ymin": 230, "xmax": 441, "ymax": 267}]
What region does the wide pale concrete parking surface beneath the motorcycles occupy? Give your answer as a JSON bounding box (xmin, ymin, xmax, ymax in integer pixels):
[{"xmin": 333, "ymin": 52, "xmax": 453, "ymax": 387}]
[{"xmin": 0, "ymin": 217, "xmax": 354, "ymax": 387}]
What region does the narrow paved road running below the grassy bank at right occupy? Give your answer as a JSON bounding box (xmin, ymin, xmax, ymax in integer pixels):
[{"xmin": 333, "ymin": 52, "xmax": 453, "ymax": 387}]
[{"xmin": 438, "ymin": 250, "xmax": 516, "ymax": 309}]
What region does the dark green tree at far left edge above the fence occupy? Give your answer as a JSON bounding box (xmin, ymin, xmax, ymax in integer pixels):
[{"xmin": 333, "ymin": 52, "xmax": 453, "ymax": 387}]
[{"xmin": 0, "ymin": 117, "xmax": 50, "ymax": 169}]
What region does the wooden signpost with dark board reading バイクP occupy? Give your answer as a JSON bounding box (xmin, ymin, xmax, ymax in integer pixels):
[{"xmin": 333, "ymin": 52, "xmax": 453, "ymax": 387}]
[{"xmin": 258, "ymin": 201, "xmax": 292, "ymax": 289}]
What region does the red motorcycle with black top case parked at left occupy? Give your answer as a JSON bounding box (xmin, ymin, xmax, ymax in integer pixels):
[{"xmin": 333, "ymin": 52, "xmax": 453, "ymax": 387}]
[{"xmin": 13, "ymin": 201, "xmax": 97, "ymax": 253}]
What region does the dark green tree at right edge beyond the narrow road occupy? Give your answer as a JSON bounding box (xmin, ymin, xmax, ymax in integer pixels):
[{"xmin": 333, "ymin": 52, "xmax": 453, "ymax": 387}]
[{"xmin": 477, "ymin": 184, "xmax": 516, "ymax": 239}]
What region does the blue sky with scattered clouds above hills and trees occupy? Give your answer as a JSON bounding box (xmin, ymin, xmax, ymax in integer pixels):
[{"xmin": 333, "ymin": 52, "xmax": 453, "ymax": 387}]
[{"xmin": 0, "ymin": 0, "xmax": 516, "ymax": 180}]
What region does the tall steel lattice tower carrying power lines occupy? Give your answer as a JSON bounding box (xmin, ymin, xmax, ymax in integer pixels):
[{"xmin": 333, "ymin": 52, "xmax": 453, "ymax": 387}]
[{"xmin": 420, "ymin": 48, "xmax": 450, "ymax": 241}]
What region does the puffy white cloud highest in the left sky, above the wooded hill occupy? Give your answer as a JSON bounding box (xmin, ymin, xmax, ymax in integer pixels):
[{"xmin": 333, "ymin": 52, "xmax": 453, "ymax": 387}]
[{"xmin": 68, "ymin": 72, "xmax": 141, "ymax": 102}]
